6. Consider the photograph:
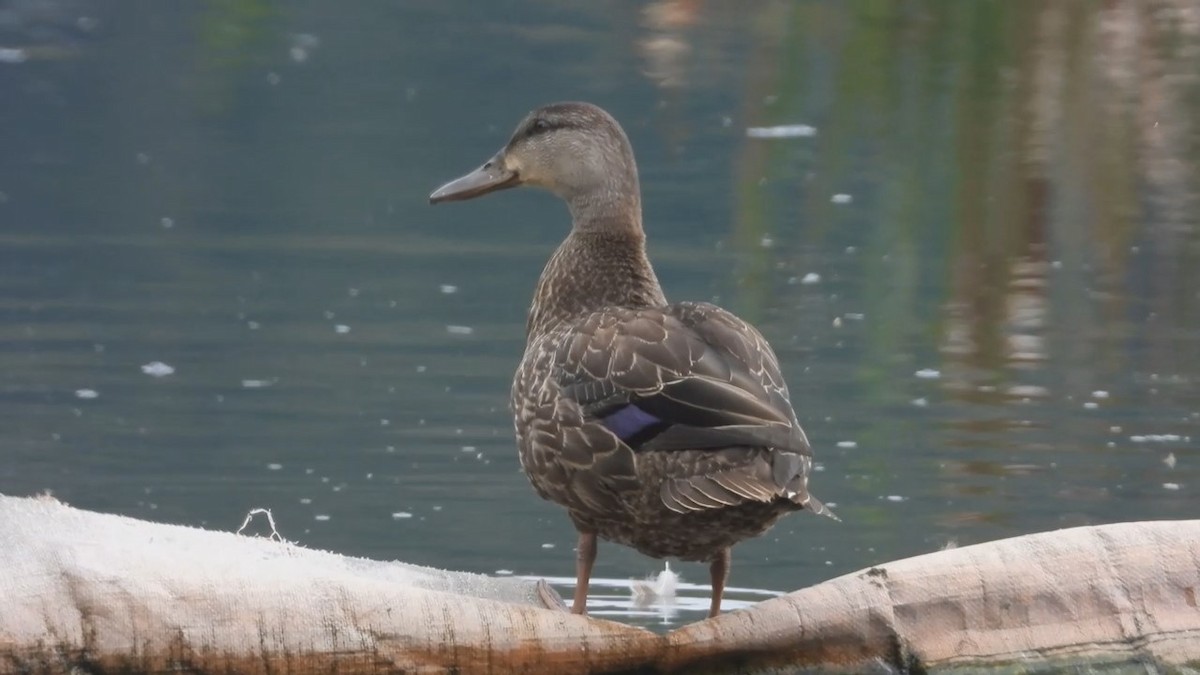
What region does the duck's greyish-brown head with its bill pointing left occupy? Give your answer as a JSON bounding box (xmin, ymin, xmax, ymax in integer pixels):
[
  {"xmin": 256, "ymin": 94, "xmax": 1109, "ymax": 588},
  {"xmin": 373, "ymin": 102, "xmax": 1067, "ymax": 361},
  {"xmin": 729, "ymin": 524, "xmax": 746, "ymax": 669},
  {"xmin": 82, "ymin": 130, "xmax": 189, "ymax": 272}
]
[{"xmin": 430, "ymin": 102, "xmax": 641, "ymax": 222}]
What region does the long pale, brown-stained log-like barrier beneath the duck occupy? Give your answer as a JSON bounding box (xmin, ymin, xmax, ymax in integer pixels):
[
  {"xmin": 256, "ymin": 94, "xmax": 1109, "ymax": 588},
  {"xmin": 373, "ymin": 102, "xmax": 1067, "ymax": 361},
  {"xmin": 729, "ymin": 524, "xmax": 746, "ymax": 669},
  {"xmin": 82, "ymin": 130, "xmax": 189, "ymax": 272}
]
[{"xmin": 0, "ymin": 496, "xmax": 1200, "ymax": 674}]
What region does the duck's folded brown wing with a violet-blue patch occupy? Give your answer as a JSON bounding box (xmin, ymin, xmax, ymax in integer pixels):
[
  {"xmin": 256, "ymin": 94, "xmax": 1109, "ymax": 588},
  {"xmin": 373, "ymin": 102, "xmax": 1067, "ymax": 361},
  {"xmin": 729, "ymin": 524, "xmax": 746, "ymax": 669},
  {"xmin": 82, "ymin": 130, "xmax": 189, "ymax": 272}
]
[{"xmin": 554, "ymin": 303, "xmax": 811, "ymax": 454}]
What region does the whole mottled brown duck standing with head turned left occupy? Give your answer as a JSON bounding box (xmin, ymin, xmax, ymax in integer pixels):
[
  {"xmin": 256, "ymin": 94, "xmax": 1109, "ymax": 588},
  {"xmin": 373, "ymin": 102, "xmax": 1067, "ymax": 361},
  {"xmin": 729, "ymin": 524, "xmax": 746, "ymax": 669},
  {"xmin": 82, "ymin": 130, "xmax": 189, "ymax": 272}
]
[{"xmin": 430, "ymin": 102, "xmax": 835, "ymax": 617}]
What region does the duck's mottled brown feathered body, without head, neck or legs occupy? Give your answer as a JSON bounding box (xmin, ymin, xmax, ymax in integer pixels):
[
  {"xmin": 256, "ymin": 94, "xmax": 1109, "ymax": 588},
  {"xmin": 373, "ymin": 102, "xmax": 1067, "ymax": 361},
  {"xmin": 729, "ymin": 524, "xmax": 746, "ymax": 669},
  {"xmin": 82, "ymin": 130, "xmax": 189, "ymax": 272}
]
[{"xmin": 512, "ymin": 293, "xmax": 832, "ymax": 560}]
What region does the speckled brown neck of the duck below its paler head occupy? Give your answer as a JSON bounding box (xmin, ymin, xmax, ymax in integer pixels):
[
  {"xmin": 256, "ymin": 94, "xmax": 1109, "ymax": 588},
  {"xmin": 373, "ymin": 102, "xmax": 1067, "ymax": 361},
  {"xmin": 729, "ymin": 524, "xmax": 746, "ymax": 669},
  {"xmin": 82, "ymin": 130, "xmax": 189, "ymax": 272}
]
[{"xmin": 527, "ymin": 219, "xmax": 666, "ymax": 340}]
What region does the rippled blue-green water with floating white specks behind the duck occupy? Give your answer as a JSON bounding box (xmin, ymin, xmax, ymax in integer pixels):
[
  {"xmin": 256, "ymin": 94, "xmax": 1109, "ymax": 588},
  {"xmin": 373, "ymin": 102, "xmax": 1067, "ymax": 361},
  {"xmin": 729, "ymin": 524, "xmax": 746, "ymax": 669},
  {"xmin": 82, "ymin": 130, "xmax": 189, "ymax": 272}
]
[{"xmin": 0, "ymin": 0, "xmax": 1200, "ymax": 626}]
